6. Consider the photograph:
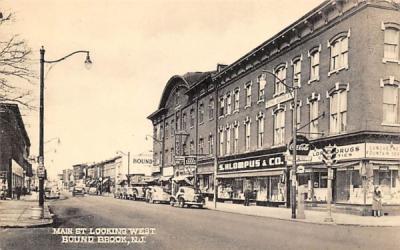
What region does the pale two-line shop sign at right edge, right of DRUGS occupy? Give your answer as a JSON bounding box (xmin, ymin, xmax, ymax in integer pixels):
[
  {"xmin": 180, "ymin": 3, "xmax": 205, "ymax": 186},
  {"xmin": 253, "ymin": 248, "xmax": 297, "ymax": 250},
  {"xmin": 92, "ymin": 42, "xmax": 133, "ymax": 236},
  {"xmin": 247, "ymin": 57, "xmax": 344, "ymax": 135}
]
[{"xmin": 366, "ymin": 143, "xmax": 400, "ymax": 160}]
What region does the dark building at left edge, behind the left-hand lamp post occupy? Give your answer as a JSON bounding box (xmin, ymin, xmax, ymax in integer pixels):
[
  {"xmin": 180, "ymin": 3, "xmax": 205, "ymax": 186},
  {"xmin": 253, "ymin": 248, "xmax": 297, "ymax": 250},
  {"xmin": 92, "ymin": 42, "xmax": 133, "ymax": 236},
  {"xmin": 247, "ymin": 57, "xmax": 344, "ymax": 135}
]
[{"xmin": 0, "ymin": 103, "xmax": 32, "ymax": 198}]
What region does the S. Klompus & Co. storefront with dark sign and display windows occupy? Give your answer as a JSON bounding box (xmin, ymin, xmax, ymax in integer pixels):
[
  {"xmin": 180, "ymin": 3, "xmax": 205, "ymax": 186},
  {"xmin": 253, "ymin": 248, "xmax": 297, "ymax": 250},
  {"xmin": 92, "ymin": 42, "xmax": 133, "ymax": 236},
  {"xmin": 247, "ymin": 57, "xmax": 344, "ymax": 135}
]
[{"xmin": 217, "ymin": 154, "xmax": 287, "ymax": 206}]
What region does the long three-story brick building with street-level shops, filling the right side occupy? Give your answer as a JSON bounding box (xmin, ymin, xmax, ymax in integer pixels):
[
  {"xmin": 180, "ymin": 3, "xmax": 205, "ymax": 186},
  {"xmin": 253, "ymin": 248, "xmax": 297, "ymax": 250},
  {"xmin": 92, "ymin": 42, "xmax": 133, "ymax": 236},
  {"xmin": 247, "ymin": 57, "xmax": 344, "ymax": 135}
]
[{"xmin": 148, "ymin": 0, "xmax": 400, "ymax": 215}]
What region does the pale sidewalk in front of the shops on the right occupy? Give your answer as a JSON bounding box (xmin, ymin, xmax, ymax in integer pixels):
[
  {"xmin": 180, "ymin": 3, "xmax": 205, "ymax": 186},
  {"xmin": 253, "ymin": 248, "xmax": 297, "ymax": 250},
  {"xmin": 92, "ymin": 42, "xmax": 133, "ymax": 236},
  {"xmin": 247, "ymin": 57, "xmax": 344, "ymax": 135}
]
[{"xmin": 206, "ymin": 201, "xmax": 400, "ymax": 227}]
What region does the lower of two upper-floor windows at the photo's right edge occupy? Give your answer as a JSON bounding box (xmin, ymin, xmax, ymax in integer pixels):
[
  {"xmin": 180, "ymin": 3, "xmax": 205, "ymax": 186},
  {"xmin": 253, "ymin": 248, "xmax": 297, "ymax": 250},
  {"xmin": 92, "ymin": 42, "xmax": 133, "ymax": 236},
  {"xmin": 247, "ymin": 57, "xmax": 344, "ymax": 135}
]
[{"xmin": 383, "ymin": 84, "xmax": 400, "ymax": 124}]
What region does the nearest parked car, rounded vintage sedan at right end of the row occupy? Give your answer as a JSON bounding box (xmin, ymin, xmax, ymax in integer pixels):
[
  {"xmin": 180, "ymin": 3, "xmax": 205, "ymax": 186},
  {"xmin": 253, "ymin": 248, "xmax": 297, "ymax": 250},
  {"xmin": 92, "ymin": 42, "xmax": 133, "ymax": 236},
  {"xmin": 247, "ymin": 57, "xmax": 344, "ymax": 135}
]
[{"xmin": 170, "ymin": 186, "xmax": 205, "ymax": 208}]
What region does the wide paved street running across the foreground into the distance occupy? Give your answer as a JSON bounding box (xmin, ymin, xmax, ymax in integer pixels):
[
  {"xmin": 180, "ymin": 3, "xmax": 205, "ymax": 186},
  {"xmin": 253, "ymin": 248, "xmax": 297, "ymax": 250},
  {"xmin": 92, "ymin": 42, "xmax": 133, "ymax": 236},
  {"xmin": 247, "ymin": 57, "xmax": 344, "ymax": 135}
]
[{"xmin": 0, "ymin": 196, "xmax": 400, "ymax": 250}]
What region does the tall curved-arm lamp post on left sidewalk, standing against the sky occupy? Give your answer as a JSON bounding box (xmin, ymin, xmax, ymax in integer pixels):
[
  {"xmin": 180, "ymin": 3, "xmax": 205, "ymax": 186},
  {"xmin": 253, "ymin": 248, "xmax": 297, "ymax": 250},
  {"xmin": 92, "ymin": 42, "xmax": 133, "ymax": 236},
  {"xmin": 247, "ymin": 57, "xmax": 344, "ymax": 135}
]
[{"xmin": 38, "ymin": 46, "xmax": 92, "ymax": 207}]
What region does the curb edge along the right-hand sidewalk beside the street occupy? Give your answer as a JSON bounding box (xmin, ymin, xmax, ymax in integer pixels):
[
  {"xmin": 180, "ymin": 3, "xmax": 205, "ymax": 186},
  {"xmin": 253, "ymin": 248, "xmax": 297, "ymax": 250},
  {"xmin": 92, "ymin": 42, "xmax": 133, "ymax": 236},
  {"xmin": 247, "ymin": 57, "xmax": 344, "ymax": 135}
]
[{"xmin": 206, "ymin": 207, "xmax": 400, "ymax": 227}]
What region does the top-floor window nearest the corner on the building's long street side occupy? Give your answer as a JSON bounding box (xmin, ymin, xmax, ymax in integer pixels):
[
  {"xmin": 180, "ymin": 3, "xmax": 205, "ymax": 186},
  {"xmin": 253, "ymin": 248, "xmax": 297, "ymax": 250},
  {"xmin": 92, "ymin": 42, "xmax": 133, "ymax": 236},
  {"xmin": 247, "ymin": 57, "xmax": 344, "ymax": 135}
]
[{"xmin": 330, "ymin": 36, "xmax": 349, "ymax": 71}]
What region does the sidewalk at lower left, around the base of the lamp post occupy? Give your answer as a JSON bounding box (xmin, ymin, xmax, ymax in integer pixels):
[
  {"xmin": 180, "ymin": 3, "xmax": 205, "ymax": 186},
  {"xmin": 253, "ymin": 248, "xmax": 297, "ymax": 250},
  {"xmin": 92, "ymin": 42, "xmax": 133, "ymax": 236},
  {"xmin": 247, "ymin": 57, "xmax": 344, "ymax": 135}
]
[{"xmin": 0, "ymin": 192, "xmax": 53, "ymax": 228}]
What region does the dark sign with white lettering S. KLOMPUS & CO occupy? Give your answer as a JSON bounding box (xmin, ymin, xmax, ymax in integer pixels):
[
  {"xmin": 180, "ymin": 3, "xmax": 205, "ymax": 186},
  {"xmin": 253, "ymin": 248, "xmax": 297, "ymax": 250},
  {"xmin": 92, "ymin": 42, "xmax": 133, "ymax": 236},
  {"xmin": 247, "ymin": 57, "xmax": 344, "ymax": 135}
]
[{"xmin": 218, "ymin": 155, "xmax": 285, "ymax": 172}]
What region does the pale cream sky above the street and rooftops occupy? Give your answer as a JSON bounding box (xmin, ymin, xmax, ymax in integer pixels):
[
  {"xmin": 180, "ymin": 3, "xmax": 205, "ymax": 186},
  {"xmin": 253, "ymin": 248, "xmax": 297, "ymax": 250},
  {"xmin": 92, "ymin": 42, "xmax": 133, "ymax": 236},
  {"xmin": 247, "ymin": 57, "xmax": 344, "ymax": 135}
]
[{"xmin": 0, "ymin": 0, "xmax": 323, "ymax": 180}]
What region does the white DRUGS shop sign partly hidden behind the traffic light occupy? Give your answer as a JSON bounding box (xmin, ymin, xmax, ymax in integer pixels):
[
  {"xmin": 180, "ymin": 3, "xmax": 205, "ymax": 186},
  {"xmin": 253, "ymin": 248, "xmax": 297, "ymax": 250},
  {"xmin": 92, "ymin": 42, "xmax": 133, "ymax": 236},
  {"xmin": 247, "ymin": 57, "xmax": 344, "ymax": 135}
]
[{"xmin": 310, "ymin": 143, "xmax": 365, "ymax": 162}]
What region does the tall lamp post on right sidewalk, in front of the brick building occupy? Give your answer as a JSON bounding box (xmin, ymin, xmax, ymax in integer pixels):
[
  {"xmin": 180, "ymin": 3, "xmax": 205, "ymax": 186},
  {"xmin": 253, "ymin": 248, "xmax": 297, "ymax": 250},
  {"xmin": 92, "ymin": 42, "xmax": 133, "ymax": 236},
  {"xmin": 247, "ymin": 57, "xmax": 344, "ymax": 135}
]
[{"xmin": 262, "ymin": 70, "xmax": 299, "ymax": 219}]
